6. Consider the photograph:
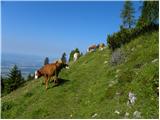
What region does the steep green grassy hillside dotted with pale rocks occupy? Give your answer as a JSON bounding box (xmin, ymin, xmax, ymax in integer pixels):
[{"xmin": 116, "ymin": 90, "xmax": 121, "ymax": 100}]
[{"xmin": 2, "ymin": 32, "xmax": 159, "ymax": 118}]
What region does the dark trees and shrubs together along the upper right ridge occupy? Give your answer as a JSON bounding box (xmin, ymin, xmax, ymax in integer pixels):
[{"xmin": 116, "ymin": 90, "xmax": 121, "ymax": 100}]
[{"xmin": 107, "ymin": 1, "xmax": 159, "ymax": 50}]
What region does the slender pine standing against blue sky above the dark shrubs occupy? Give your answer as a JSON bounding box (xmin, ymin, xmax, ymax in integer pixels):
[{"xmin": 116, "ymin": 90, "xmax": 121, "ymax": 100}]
[{"xmin": 121, "ymin": 1, "xmax": 135, "ymax": 28}]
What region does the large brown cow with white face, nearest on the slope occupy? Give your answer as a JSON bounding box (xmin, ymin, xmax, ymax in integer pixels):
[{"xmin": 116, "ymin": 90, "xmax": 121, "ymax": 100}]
[{"xmin": 35, "ymin": 60, "xmax": 68, "ymax": 89}]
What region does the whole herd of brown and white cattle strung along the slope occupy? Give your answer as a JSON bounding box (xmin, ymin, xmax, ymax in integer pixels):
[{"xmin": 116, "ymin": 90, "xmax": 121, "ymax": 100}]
[{"xmin": 35, "ymin": 43, "xmax": 105, "ymax": 89}]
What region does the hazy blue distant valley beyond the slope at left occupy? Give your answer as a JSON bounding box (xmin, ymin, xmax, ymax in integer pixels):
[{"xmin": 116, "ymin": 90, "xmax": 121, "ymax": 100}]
[{"xmin": 1, "ymin": 53, "xmax": 55, "ymax": 78}]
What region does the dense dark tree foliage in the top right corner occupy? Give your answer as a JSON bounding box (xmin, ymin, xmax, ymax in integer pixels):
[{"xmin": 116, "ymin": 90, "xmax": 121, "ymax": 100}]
[{"xmin": 136, "ymin": 1, "xmax": 159, "ymax": 27}]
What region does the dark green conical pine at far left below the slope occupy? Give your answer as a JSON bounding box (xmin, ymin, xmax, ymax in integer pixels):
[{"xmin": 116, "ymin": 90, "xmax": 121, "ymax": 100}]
[{"xmin": 7, "ymin": 65, "xmax": 24, "ymax": 92}]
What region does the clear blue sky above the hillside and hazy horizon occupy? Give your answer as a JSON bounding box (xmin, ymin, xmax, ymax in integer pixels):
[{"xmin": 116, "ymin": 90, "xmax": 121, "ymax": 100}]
[{"xmin": 1, "ymin": 1, "xmax": 141, "ymax": 58}]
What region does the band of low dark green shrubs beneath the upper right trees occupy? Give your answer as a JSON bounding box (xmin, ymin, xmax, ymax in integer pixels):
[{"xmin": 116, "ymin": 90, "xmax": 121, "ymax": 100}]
[{"xmin": 107, "ymin": 24, "xmax": 159, "ymax": 50}]
